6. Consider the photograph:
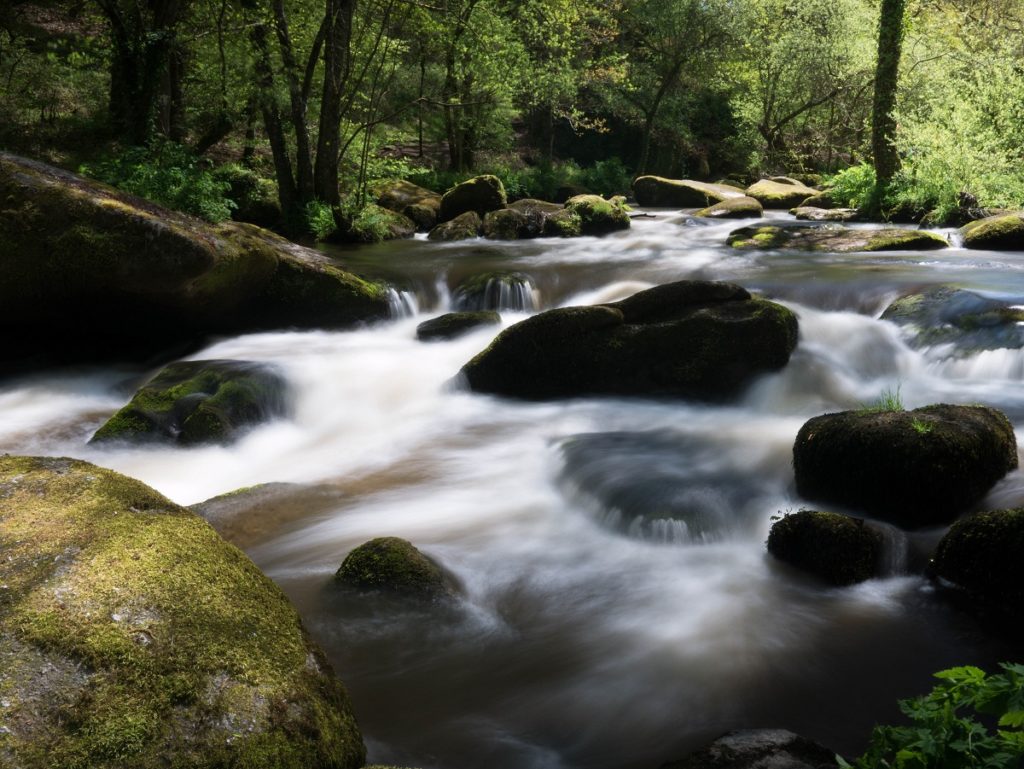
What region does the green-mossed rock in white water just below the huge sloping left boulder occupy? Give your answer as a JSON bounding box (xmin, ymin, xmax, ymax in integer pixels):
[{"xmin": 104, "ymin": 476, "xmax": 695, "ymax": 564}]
[{"xmin": 90, "ymin": 360, "xmax": 287, "ymax": 445}]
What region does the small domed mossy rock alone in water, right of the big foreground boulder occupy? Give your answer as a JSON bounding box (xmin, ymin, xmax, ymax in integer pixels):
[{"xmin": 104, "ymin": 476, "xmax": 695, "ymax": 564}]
[{"xmin": 334, "ymin": 537, "xmax": 457, "ymax": 599}]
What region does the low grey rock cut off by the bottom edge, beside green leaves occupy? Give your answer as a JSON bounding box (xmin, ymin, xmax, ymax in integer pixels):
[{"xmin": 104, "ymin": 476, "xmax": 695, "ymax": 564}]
[{"xmin": 662, "ymin": 729, "xmax": 836, "ymax": 769}]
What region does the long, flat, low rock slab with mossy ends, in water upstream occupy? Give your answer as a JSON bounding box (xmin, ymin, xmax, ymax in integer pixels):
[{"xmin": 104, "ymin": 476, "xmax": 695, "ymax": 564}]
[{"xmin": 726, "ymin": 224, "xmax": 949, "ymax": 254}]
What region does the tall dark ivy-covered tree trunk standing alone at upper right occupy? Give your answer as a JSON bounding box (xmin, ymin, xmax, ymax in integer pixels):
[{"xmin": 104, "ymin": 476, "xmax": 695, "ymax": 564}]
[{"xmin": 868, "ymin": 0, "xmax": 906, "ymax": 214}]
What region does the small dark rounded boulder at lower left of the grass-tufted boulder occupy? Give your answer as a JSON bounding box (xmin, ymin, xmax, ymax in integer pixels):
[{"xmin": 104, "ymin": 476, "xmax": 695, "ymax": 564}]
[{"xmin": 768, "ymin": 510, "xmax": 883, "ymax": 586}]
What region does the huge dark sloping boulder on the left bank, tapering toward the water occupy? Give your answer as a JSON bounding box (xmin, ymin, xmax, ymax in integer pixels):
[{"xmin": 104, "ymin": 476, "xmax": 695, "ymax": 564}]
[{"xmin": 0, "ymin": 154, "xmax": 388, "ymax": 368}]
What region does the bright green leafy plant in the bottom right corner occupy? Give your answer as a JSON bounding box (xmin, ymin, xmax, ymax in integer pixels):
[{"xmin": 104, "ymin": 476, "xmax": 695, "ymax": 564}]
[{"xmin": 837, "ymin": 663, "xmax": 1024, "ymax": 769}]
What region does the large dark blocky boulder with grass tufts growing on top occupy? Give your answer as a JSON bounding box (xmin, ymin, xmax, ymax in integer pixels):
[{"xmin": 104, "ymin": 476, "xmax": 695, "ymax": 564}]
[{"xmin": 793, "ymin": 403, "xmax": 1017, "ymax": 528}]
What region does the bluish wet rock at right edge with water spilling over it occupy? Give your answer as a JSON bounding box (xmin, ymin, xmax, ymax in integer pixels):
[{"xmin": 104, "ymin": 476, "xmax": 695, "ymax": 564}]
[{"xmin": 882, "ymin": 286, "xmax": 1024, "ymax": 354}]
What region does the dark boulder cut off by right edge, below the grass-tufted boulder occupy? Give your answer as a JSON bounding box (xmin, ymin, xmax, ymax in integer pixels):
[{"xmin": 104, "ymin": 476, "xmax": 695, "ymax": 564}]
[{"xmin": 932, "ymin": 508, "xmax": 1024, "ymax": 631}]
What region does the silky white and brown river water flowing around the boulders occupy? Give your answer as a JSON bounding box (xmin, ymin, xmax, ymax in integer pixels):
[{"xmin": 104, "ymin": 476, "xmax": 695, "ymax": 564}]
[{"xmin": 0, "ymin": 211, "xmax": 1024, "ymax": 769}]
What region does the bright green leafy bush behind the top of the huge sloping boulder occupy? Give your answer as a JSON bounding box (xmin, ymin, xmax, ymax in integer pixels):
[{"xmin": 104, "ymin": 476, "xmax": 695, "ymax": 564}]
[{"xmin": 79, "ymin": 141, "xmax": 234, "ymax": 222}]
